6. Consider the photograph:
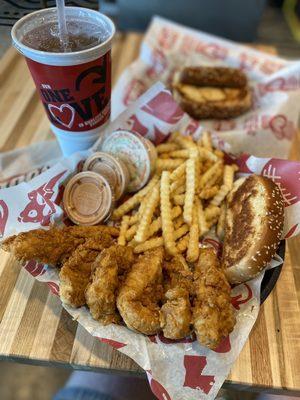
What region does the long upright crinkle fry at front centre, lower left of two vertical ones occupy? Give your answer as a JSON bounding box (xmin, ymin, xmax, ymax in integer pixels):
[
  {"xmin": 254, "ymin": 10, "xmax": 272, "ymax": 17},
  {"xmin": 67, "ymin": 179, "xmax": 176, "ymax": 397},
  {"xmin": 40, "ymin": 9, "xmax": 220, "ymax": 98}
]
[{"xmin": 160, "ymin": 171, "xmax": 177, "ymax": 255}]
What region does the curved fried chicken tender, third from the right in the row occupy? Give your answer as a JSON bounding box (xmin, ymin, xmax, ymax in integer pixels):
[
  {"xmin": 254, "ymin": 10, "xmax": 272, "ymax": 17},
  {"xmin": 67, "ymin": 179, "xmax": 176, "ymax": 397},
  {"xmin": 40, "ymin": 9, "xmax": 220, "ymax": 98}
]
[{"xmin": 117, "ymin": 247, "xmax": 164, "ymax": 335}]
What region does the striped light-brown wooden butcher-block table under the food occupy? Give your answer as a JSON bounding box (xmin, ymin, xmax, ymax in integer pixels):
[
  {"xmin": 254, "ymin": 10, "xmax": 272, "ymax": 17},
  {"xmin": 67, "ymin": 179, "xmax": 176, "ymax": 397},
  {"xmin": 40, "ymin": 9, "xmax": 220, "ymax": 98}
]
[{"xmin": 0, "ymin": 33, "xmax": 300, "ymax": 394}]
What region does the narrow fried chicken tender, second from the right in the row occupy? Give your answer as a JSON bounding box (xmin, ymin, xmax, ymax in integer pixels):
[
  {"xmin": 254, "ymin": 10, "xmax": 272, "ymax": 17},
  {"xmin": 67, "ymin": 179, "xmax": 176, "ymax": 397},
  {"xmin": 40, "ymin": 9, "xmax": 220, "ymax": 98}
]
[{"xmin": 160, "ymin": 256, "xmax": 193, "ymax": 339}]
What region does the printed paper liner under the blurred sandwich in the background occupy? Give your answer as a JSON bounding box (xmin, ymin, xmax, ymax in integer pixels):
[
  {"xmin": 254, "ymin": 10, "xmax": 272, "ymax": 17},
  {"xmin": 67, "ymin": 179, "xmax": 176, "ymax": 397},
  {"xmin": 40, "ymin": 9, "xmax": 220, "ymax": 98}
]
[{"xmin": 112, "ymin": 17, "xmax": 300, "ymax": 158}]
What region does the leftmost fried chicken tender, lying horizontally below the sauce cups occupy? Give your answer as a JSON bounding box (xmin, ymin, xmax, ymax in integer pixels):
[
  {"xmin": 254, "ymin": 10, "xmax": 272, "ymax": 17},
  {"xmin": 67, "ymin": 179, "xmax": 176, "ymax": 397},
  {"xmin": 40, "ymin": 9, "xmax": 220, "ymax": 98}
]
[{"xmin": 1, "ymin": 226, "xmax": 118, "ymax": 265}]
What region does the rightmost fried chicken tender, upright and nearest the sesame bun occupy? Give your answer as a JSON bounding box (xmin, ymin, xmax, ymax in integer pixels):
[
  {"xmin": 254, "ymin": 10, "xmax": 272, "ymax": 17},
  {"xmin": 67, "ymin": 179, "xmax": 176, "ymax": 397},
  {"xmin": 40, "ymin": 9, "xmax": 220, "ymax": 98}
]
[{"xmin": 193, "ymin": 248, "xmax": 235, "ymax": 349}]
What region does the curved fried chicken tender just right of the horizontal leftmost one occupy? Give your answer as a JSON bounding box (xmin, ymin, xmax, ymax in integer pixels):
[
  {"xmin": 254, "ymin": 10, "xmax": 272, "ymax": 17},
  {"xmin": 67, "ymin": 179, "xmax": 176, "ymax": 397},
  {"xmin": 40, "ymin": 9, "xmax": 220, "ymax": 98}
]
[{"xmin": 59, "ymin": 235, "xmax": 113, "ymax": 307}]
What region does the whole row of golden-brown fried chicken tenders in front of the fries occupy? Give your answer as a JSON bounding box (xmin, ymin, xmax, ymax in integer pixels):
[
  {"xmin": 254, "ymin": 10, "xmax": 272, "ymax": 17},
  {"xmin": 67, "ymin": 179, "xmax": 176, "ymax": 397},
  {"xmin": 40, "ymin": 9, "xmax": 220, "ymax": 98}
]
[{"xmin": 1, "ymin": 226, "xmax": 235, "ymax": 349}]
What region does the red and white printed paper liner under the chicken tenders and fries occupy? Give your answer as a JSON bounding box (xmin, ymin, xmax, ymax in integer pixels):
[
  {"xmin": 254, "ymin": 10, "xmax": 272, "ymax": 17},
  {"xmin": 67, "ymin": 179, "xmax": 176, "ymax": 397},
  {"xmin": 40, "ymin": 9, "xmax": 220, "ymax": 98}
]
[{"xmin": 0, "ymin": 83, "xmax": 300, "ymax": 400}]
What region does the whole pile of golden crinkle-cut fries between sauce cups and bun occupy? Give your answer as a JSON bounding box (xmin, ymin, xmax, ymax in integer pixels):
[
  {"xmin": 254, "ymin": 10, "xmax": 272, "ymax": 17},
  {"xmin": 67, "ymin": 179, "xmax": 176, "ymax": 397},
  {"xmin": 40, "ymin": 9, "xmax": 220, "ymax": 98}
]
[{"xmin": 112, "ymin": 132, "xmax": 238, "ymax": 262}]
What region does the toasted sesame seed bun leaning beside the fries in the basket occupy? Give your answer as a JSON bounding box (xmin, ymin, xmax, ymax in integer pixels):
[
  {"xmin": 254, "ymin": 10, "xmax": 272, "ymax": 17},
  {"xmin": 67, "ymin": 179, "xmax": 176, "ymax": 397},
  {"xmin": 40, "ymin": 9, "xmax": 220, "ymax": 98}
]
[{"xmin": 222, "ymin": 175, "xmax": 284, "ymax": 284}]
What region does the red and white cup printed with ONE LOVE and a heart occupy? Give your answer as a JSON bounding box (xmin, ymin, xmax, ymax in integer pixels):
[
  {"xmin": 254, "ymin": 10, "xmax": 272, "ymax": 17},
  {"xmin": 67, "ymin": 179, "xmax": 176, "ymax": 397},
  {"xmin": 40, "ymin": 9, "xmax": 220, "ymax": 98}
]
[{"xmin": 11, "ymin": 7, "xmax": 115, "ymax": 155}]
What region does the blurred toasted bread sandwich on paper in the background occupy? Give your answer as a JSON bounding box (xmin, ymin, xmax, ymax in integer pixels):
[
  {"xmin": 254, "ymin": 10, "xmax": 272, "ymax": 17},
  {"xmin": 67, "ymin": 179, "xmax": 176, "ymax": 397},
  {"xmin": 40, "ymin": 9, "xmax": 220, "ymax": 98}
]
[{"xmin": 172, "ymin": 67, "xmax": 252, "ymax": 119}]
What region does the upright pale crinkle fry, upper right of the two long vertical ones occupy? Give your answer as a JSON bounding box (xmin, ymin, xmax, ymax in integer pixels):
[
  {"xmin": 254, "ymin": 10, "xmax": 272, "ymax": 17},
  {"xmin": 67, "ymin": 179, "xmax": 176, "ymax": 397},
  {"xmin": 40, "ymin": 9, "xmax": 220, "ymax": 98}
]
[{"xmin": 183, "ymin": 158, "xmax": 196, "ymax": 225}]
